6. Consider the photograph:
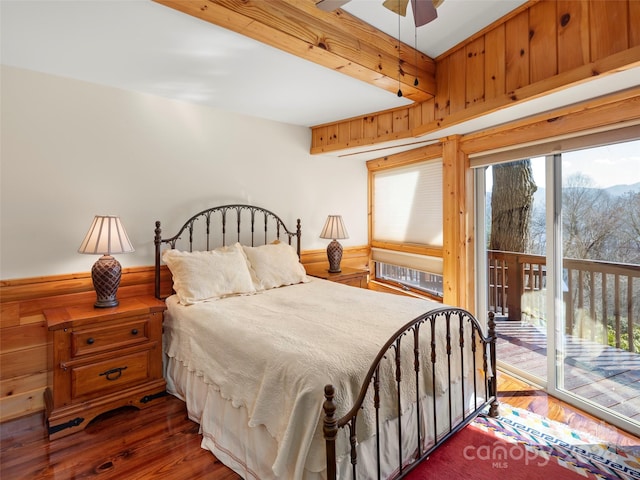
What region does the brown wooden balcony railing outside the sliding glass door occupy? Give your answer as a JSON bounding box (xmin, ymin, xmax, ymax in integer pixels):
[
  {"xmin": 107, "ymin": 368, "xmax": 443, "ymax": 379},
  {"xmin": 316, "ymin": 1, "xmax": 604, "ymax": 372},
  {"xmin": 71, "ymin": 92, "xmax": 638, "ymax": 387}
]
[{"xmin": 487, "ymin": 250, "xmax": 640, "ymax": 352}]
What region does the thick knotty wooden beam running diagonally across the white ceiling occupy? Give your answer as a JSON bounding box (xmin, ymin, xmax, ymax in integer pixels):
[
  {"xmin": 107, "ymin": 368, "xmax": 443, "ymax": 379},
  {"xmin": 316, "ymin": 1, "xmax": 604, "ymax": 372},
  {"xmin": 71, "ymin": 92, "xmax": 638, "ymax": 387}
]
[{"xmin": 154, "ymin": 0, "xmax": 436, "ymax": 102}]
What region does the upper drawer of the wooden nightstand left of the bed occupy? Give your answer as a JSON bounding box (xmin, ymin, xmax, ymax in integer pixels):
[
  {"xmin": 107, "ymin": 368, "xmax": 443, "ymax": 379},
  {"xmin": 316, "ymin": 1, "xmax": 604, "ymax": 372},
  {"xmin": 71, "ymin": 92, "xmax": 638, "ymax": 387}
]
[{"xmin": 71, "ymin": 316, "xmax": 149, "ymax": 357}]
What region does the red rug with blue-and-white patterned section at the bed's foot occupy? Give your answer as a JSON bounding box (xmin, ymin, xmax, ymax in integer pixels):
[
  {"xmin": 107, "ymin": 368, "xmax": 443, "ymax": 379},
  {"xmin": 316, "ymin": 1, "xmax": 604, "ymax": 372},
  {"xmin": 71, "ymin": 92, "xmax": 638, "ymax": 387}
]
[{"xmin": 406, "ymin": 404, "xmax": 640, "ymax": 480}]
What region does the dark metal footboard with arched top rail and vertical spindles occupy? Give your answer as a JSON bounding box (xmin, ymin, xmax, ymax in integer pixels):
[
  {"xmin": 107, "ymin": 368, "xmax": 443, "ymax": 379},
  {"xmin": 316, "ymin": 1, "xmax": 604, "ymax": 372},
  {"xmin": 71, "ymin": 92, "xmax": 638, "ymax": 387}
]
[{"xmin": 323, "ymin": 307, "xmax": 498, "ymax": 480}]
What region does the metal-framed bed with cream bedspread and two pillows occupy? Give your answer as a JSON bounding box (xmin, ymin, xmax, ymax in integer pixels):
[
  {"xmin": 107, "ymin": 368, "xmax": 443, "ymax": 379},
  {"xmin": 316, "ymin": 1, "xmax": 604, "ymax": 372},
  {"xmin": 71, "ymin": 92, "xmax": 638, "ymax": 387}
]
[{"xmin": 154, "ymin": 205, "xmax": 498, "ymax": 480}]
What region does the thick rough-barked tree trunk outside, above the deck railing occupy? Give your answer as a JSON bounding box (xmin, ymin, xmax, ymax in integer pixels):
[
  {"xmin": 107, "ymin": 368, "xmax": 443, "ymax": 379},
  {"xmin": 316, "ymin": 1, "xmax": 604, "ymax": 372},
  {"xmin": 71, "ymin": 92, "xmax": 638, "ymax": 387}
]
[{"xmin": 489, "ymin": 159, "xmax": 538, "ymax": 252}]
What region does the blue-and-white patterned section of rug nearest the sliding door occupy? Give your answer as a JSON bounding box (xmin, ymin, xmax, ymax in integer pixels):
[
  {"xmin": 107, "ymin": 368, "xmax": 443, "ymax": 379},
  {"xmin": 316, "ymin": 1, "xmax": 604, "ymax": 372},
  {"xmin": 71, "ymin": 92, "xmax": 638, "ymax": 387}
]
[{"xmin": 473, "ymin": 404, "xmax": 640, "ymax": 480}]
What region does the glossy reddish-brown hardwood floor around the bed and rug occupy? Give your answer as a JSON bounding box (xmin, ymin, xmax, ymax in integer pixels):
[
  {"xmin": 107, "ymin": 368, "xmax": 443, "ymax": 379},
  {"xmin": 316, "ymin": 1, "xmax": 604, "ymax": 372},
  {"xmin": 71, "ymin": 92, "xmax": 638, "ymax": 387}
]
[{"xmin": 0, "ymin": 374, "xmax": 640, "ymax": 480}]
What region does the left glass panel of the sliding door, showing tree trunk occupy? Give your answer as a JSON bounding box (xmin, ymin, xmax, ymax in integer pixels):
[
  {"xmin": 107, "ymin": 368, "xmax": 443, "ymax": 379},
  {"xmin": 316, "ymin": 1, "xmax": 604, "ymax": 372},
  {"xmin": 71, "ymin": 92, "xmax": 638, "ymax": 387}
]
[{"xmin": 485, "ymin": 157, "xmax": 548, "ymax": 384}]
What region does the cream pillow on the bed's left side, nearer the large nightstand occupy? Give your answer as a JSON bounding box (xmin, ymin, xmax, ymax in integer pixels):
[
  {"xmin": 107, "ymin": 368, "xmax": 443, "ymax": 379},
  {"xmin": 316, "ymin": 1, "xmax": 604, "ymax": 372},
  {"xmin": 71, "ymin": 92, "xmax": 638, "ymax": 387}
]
[{"xmin": 162, "ymin": 244, "xmax": 256, "ymax": 305}]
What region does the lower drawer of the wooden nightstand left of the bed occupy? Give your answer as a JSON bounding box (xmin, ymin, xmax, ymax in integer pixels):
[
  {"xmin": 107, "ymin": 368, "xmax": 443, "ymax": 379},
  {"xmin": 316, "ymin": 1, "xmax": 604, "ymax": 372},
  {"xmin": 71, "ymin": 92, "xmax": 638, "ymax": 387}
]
[{"xmin": 71, "ymin": 350, "xmax": 149, "ymax": 399}]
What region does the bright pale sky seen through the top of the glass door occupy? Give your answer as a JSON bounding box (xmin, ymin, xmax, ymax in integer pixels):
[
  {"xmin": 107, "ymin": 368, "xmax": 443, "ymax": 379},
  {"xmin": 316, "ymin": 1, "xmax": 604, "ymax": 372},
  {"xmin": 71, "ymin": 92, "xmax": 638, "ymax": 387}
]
[{"xmin": 532, "ymin": 140, "xmax": 640, "ymax": 188}]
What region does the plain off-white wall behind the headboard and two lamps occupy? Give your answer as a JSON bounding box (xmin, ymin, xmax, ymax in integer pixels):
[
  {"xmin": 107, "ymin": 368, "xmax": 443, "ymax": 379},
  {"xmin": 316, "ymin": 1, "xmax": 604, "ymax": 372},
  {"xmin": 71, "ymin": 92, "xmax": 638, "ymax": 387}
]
[{"xmin": 0, "ymin": 66, "xmax": 367, "ymax": 280}]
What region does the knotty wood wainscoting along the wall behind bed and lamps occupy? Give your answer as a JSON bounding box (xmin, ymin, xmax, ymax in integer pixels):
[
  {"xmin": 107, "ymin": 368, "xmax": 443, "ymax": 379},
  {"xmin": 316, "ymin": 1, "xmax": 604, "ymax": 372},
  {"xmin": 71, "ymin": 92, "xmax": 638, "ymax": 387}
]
[{"xmin": 0, "ymin": 246, "xmax": 370, "ymax": 422}]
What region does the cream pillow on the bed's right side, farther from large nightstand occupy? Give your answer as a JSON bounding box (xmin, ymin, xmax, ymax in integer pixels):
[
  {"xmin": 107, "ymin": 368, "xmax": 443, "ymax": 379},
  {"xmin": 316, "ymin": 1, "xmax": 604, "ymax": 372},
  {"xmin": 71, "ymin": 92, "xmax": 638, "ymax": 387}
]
[{"xmin": 242, "ymin": 242, "xmax": 309, "ymax": 290}]
